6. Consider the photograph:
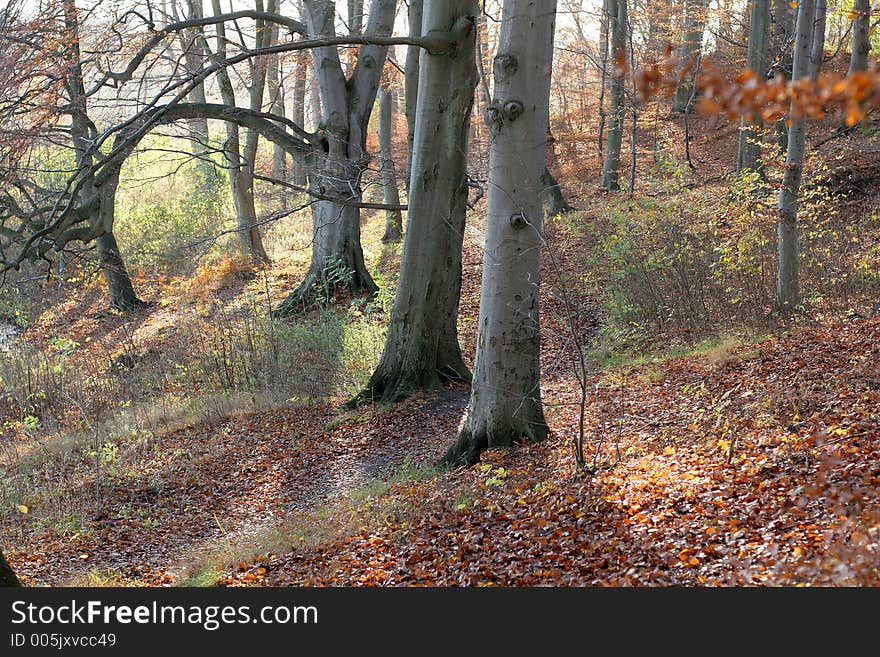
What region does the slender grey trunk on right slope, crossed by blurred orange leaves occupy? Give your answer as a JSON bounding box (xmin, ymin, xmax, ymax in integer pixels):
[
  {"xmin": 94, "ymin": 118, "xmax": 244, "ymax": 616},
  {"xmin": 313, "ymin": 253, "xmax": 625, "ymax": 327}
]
[{"xmin": 776, "ymin": 0, "xmax": 815, "ymax": 312}]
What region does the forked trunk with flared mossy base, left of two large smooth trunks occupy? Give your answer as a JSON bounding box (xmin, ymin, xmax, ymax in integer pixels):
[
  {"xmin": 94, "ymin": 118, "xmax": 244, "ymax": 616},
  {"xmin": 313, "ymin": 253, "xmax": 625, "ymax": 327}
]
[{"xmin": 275, "ymin": 0, "xmax": 396, "ymax": 316}]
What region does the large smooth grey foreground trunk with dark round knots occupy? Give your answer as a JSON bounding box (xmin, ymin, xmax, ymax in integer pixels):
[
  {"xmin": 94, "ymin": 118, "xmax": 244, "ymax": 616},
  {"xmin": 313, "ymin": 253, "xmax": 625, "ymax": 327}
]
[{"xmin": 443, "ymin": 0, "xmax": 556, "ymax": 465}]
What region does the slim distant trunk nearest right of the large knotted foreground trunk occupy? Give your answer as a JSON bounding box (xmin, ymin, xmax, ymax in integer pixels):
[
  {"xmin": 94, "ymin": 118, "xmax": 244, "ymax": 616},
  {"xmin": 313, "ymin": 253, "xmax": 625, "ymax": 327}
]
[{"xmin": 599, "ymin": 0, "xmax": 627, "ymax": 192}]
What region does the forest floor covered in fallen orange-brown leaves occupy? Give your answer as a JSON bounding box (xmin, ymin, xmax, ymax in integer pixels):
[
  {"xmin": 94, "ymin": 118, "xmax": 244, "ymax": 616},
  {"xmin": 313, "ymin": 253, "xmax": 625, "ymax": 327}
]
[{"xmin": 0, "ymin": 111, "xmax": 880, "ymax": 586}]
